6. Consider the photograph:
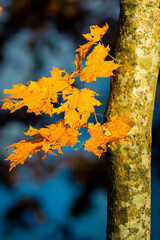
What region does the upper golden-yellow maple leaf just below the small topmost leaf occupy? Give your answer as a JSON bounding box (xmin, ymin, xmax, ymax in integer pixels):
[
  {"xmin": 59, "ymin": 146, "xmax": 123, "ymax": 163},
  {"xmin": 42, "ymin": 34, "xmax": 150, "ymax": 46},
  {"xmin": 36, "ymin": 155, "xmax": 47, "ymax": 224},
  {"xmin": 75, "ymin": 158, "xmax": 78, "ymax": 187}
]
[{"xmin": 80, "ymin": 43, "xmax": 119, "ymax": 83}]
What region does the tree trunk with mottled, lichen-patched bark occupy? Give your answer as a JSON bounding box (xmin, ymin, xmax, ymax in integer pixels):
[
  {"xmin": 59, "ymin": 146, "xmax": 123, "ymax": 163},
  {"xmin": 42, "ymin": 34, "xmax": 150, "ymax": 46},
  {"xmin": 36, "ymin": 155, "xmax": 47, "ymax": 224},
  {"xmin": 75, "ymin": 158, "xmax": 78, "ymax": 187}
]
[{"xmin": 105, "ymin": 0, "xmax": 160, "ymax": 240}]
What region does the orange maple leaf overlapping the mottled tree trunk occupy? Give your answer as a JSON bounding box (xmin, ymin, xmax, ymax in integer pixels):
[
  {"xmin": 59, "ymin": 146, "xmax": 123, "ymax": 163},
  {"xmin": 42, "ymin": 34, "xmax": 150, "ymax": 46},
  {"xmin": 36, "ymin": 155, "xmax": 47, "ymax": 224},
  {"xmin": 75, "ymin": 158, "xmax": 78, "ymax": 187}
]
[{"xmin": 83, "ymin": 116, "xmax": 134, "ymax": 158}]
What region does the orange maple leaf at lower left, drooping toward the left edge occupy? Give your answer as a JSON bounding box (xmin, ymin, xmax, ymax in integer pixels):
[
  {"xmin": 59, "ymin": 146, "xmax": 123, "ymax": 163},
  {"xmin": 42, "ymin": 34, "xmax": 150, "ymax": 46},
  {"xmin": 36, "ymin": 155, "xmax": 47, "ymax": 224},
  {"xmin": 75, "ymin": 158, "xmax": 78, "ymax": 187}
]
[{"xmin": 5, "ymin": 120, "xmax": 80, "ymax": 171}]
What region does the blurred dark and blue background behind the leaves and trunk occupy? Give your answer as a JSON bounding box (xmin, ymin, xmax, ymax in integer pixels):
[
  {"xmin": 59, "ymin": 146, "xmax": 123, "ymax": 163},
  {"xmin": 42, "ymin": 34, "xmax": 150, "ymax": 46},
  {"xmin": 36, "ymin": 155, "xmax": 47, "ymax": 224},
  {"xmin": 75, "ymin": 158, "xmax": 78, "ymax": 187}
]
[{"xmin": 0, "ymin": 0, "xmax": 160, "ymax": 240}]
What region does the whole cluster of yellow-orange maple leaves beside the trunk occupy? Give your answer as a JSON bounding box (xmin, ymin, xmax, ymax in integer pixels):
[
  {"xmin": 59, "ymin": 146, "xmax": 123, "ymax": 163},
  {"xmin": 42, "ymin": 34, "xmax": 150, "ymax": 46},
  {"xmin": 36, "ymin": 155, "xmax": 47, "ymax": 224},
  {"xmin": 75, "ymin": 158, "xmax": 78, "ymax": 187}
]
[{"xmin": 2, "ymin": 24, "xmax": 133, "ymax": 170}]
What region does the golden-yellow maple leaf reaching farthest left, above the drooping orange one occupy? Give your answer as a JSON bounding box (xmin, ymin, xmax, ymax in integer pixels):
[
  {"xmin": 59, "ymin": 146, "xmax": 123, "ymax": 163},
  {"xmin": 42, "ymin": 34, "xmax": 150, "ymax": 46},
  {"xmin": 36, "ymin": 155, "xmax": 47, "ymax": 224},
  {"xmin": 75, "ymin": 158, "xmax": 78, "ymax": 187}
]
[{"xmin": 2, "ymin": 67, "xmax": 74, "ymax": 116}]
